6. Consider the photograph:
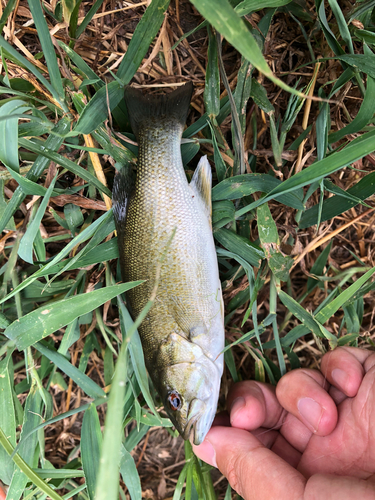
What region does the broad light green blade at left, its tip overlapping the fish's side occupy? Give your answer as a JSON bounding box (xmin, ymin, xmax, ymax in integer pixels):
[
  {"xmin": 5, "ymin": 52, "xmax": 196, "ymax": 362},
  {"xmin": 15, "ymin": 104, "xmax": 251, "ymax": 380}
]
[{"xmin": 4, "ymin": 281, "xmax": 141, "ymax": 350}]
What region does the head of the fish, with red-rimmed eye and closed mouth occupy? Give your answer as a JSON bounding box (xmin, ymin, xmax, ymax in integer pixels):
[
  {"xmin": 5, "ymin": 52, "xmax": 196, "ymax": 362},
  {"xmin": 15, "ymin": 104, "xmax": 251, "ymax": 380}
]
[{"xmin": 159, "ymin": 358, "xmax": 222, "ymax": 445}]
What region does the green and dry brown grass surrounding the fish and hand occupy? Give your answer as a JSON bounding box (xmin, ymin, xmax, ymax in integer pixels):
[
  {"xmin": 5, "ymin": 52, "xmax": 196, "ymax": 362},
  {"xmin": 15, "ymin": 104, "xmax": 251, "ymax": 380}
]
[{"xmin": 0, "ymin": 0, "xmax": 375, "ymax": 500}]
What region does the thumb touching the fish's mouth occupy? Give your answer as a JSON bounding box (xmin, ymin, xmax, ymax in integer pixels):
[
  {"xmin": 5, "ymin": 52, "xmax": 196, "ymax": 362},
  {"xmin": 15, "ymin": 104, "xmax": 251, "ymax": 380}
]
[{"xmin": 193, "ymin": 426, "xmax": 306, "ymax": 500}]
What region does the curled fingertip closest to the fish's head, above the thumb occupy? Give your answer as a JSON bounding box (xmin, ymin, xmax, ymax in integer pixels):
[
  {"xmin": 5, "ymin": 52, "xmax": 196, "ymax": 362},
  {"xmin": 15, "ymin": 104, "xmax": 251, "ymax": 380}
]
[{"xmin": 227, "ymin": 380, "xmax": 284, "ymax": 431}]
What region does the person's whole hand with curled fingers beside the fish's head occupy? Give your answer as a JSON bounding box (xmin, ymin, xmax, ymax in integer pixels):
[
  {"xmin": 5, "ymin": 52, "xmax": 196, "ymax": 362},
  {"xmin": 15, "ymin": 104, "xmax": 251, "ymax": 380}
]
[{"xmin": 193, "ymin": 347, "xmax": 375, "ymax": 500}]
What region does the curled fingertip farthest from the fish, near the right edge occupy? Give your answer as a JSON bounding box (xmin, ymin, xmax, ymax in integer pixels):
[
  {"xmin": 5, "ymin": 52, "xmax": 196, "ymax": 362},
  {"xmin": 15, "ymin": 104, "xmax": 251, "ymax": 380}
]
[{"xmin": 321, "ymin": 347, "xmax": 371, "ymax": 398}]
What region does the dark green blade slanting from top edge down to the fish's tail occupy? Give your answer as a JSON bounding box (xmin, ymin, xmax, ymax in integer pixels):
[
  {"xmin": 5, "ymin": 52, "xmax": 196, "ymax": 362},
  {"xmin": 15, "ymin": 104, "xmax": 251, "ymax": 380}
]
[{"xmin": 117, "ymin": 0, "xmax": 170, "ymax": 85}]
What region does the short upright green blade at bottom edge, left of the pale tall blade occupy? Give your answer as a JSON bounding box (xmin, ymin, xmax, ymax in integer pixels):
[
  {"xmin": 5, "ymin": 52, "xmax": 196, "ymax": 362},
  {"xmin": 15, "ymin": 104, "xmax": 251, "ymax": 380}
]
[{"xmin": 81, "ymin": 404, "xmax": 103, "ymax": 500}]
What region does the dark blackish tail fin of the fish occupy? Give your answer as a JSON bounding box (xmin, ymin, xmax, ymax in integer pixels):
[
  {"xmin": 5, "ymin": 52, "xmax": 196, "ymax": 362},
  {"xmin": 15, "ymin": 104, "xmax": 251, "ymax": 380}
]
[{"xmin": 125, "ymin": 82, "xmax": 193, "ymax": 137}]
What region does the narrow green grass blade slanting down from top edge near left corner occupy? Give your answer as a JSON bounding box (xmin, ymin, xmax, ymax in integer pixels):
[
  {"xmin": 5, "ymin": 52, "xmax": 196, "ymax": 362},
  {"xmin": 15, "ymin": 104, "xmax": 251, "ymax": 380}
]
[{"xmin": 28, "ymin": 0, "xmax": 65, "ymax": 102}]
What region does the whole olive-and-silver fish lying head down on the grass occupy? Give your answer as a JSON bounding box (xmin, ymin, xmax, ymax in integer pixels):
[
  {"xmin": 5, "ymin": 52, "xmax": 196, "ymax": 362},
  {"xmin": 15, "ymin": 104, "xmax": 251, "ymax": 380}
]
[{"xmin": 113, "ymin": 83, "xmax": 225, "ymax": 445}]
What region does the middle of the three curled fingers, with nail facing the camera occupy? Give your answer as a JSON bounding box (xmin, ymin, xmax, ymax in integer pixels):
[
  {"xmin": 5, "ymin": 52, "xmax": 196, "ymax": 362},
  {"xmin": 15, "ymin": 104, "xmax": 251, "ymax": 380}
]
[{"xmin": 276, "ymin": 369, "xmax": 337, "ymax": 436}]
